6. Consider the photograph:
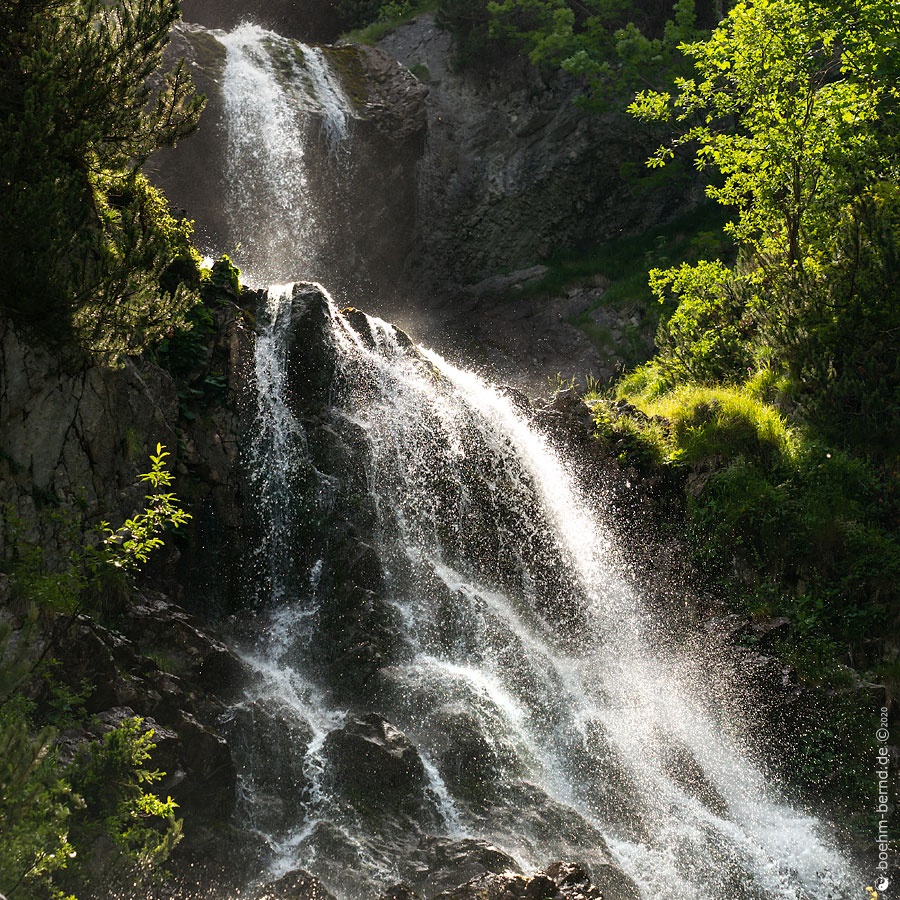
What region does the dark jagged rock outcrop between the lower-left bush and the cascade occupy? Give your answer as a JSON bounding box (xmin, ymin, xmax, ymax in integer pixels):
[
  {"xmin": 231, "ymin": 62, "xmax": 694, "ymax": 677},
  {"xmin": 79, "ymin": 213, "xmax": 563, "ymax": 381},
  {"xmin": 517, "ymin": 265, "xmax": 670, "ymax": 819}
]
[{"xmin": 47, "ymin": 594, "xmax": 240, "ymax": 832}]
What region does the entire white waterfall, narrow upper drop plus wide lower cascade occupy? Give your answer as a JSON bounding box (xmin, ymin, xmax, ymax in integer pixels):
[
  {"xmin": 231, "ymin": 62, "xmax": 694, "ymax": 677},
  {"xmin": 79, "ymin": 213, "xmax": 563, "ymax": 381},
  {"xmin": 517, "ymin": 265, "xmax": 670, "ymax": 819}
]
[{"xmin": 211, "ymin": 19, "xmax": 864, "ymax": 900}]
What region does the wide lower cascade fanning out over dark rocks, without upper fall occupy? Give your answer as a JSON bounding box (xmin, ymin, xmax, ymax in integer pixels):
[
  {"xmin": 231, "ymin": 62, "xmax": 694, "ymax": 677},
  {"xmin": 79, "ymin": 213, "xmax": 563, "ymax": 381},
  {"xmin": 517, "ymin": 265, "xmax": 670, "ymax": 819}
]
[{"xmin": 234, "ymin": 285, "xmax": 861, "ymax": 900}]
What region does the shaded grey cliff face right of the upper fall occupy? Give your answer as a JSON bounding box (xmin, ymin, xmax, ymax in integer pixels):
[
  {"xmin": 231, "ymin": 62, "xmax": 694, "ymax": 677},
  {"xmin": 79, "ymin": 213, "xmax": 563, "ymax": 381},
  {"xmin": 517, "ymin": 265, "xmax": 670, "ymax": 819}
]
[{"xmin": 379, "ymin": 14, "xmax": 677, "ymax": 289}]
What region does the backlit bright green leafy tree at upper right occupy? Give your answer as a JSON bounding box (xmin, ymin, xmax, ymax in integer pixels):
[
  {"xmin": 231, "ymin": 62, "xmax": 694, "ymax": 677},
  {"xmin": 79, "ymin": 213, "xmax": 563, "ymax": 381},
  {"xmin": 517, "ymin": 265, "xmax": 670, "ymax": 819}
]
[{"xmin": 630, "ymin": 0, "xmax": 900, "ymax": 447}]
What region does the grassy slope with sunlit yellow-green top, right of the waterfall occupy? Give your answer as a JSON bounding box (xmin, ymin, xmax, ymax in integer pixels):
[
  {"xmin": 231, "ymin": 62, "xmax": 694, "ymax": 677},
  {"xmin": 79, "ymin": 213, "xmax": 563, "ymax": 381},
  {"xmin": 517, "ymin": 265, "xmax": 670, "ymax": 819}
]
[{"xmin": 593, "ymin": 363, "xmax": 900, "ymax": 652}]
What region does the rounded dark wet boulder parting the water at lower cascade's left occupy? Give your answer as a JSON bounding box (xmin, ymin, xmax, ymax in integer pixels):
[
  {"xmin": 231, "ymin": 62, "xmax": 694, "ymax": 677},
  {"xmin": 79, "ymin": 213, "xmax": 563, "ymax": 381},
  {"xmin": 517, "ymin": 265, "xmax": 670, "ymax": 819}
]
[{"xmin": 323, "ymin": 713, "xmax": 426, "ymax": 806}]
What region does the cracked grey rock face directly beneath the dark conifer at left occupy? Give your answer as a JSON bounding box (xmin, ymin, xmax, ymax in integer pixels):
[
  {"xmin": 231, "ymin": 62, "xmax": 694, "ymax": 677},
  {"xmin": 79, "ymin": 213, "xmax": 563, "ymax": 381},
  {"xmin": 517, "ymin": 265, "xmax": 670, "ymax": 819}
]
[{"xmin": 0, "ymin": 319, "xmax": 178, "ymax": 553}]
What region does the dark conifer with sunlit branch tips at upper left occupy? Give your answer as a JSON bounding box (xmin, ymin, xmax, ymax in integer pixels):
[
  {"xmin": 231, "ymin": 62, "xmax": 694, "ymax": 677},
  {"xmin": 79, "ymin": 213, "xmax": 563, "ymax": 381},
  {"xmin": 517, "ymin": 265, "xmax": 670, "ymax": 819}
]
[{"xmin": 0, "ymin": 0, "xmax": 203, "ymax": 356}]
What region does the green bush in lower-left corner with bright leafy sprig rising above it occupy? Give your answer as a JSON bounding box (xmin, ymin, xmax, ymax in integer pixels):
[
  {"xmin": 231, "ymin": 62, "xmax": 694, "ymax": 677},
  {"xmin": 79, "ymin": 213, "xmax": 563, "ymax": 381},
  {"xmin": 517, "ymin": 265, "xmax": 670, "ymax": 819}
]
[{"xmin": 0, "ymin": 445, "xmax": 189, "ymax": 900}]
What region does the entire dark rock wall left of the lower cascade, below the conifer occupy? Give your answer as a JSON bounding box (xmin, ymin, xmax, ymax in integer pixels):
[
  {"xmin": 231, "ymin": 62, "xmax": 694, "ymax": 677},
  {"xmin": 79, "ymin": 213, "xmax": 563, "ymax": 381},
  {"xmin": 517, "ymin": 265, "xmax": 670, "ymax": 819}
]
[{"xmin": 0, "ymin": 297, "xmax": 260, "ymax": 866}]
